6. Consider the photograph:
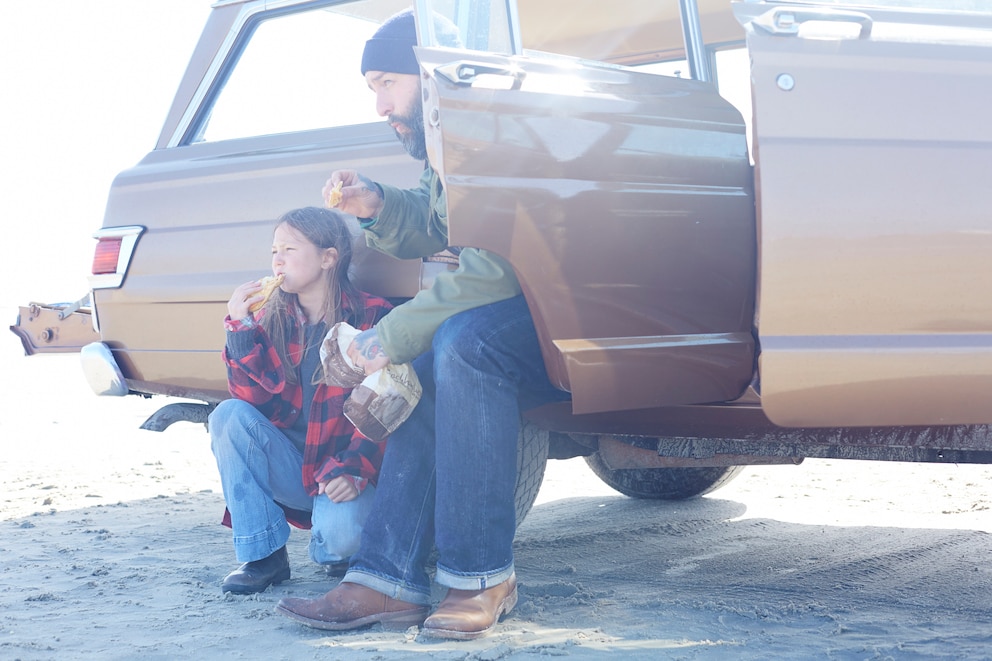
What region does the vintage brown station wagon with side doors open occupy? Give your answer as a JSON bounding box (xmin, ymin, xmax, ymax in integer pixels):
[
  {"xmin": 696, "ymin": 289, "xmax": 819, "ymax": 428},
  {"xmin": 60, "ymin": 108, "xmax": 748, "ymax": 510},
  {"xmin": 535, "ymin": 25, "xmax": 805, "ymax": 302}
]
[{"xmin": 12, "ymin": 0, "xmax": 992, "ymax": 512}]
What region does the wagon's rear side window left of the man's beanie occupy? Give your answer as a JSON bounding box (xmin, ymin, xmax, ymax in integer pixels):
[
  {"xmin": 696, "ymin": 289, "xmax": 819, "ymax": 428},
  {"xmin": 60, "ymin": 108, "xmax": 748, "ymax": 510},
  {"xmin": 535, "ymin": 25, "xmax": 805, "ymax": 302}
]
[{"xmin": 194, "ymin": 2, "xmax": 380, "ymax": 142}]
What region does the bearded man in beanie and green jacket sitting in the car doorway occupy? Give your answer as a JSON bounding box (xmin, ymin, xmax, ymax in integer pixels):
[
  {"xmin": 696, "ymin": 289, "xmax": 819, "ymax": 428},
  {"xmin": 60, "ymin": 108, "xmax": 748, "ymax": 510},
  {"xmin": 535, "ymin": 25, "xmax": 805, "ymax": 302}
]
[{"xmin": 276, "ymin": 11, "xmax": 567, "ymax": 639}]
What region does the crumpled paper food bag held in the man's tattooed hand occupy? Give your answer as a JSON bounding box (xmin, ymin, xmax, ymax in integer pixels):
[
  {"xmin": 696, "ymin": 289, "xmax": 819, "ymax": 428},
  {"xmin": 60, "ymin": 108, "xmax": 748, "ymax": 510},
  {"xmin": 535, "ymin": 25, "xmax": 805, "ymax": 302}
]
[{"xmin": 320, "ymin": 321, "xmax": 423, "ymax": 441}]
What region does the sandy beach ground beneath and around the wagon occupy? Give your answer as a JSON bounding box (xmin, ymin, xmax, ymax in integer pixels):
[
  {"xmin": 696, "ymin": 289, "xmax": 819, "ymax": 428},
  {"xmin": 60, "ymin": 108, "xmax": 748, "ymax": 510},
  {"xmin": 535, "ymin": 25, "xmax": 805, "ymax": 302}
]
[{"xmin": 0, "ymin": 318, "xmax": 992, "ymax": 660}]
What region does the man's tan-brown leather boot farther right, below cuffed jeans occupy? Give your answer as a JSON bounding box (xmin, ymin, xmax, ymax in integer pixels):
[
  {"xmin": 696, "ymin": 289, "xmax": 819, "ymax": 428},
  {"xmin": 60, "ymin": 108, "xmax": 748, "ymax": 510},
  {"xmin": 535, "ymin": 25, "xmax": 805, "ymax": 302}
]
[{"xmin": 422, "ymin": 574, "xmax": 517, "ymax": 640}]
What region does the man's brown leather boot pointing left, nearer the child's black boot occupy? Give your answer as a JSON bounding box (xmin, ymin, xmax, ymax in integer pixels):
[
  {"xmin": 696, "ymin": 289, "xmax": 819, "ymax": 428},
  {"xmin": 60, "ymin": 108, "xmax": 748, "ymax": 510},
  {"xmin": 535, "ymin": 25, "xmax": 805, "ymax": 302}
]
[{"xmin": 276, "ymin": 583, "xmax": 428, "ymax": 631}]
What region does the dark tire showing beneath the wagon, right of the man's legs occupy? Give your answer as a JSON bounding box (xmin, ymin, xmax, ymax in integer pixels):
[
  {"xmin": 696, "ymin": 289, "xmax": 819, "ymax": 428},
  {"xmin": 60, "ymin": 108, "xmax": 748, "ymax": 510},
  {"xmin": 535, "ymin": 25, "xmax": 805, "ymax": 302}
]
[{"xmin": 585, "ymin": 452, "xmax": 744, "ymax": 500}]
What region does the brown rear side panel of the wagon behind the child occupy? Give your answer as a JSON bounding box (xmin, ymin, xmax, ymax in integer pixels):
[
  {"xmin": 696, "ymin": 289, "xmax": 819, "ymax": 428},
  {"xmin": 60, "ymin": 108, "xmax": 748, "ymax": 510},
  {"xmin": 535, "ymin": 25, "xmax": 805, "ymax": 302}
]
[{"xmin": 93, "ymin": 125, "xmax": 427, "ymax": 400}]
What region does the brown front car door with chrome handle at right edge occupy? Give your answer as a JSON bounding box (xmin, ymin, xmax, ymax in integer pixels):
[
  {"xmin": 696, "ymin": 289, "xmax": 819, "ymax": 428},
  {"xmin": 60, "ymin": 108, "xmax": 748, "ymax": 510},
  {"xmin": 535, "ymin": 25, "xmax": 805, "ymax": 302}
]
[{"xmin": 736, "ymin": 0, "xmax": 992, "ymax": 427}]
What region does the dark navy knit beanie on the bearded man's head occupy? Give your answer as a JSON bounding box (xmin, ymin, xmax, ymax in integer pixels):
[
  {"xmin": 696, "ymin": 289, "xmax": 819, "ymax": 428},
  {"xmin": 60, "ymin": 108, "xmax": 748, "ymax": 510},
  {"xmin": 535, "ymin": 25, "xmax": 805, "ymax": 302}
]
[{"xmin": 362, "ymin": 9, "xmax": 461, "ymax": 76}]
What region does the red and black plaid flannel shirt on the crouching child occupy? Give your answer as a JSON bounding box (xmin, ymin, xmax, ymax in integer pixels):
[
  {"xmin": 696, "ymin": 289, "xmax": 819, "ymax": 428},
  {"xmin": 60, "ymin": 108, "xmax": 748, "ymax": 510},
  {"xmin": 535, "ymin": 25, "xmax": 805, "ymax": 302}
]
[{"xmin": 223, "ymin": 294, "xmax": 391, "ymax": 528}]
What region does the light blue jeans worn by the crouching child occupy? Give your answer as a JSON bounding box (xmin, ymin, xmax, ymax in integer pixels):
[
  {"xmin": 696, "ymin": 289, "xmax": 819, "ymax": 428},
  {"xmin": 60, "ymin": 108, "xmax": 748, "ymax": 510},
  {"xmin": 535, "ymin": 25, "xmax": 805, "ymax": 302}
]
[{"xmin": 208, "ymin": 399, "xmax": 375, "ymax": 564}]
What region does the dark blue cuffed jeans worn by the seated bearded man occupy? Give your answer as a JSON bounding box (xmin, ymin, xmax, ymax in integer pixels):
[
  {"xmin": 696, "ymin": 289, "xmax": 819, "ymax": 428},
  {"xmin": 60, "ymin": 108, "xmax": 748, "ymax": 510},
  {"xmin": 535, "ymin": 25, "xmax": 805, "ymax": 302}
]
[{"xmin": 344, "ymin": 296, "xmax": 568, "ymax": 604}]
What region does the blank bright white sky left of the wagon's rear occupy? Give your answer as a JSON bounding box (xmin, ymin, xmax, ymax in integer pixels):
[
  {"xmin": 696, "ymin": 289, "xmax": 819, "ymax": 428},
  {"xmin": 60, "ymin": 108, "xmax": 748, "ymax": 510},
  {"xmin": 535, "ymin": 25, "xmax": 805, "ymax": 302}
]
[{"xmin": 0, "ymin": 0, "xmax": 211, "ymax": 306}]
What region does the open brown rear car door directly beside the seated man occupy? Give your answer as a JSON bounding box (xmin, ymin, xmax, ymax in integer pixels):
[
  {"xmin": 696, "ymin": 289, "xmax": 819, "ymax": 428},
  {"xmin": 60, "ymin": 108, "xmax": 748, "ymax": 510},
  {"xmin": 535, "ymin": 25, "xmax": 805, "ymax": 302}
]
[{"xmin": 417, "ymin": 0, "xmax": 755, "ymax": 413}]
